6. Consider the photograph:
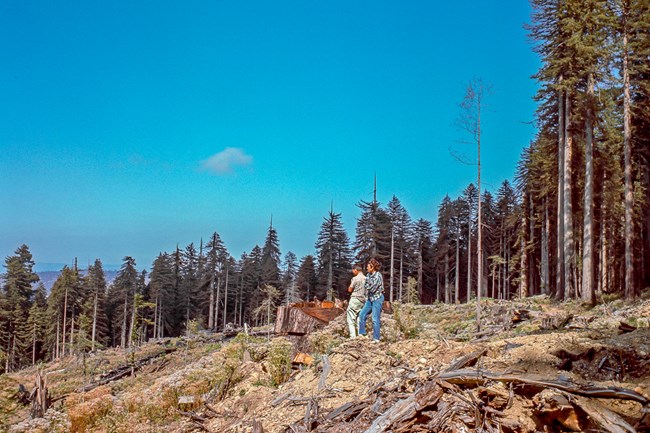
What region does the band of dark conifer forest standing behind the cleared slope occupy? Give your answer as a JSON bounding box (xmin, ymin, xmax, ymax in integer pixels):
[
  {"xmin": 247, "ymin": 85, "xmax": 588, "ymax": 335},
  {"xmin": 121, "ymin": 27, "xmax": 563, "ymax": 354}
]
[{"xmin": 0, "ymin": 0, "xmax": 650, "ymax": 371}]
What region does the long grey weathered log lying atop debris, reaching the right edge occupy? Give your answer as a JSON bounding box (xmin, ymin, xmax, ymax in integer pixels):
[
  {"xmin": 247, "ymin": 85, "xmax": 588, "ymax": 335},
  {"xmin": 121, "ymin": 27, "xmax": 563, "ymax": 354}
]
[{"xmin": 437, "ymin": 369, "xmax": 650, "ymax": 406}]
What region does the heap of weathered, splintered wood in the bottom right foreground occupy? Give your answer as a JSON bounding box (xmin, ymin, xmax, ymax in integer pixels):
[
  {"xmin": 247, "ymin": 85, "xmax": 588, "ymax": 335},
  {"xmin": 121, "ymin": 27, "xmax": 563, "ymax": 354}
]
[{"xmin": 280, "ymin": 351, "xmax": 650, "ymax": 433}]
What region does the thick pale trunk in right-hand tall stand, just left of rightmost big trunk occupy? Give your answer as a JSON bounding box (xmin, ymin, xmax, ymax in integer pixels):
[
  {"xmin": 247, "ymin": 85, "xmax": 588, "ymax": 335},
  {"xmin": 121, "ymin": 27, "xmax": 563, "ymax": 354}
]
[{"xmin": 582, "ymin": 73, "xmax": 596, "ymax": 305}]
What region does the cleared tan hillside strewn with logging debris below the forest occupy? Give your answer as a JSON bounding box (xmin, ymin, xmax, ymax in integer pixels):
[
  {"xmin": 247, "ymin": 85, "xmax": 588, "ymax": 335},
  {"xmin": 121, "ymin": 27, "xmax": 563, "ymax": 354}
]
[{"xmin": 0, "ymin": 292, "xmax": 650, "ymax": 433}]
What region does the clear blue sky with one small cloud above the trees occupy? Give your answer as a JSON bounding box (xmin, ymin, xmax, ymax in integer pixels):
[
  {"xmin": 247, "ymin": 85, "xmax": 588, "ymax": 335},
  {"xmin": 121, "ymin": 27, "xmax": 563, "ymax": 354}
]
[{"xmin": 0, "ymin": 0, "xmax": 540, "ymax": 271}]
